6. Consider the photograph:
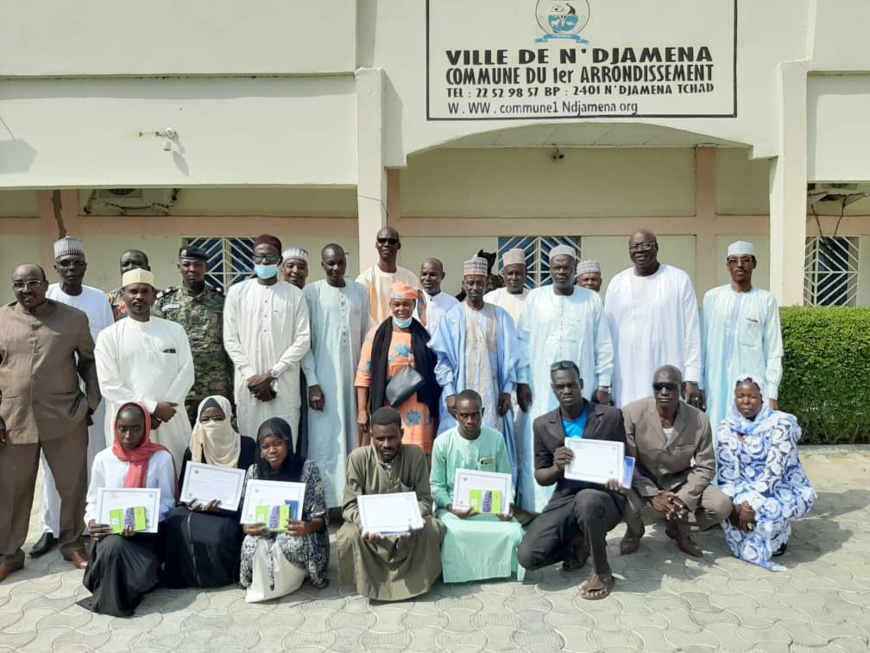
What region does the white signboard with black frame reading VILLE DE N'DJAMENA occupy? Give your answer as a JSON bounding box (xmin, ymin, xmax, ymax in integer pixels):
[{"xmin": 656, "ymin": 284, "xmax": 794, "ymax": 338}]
[{"xmin": 426, "ymin": 0, "xmax": 737, "ymax": 120}]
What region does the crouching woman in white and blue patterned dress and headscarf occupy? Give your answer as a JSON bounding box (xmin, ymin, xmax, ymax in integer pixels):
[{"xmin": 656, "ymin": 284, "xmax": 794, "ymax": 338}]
[{"xmin": 716, "ymin": 375, "xmax": 816, "ymax": 571}]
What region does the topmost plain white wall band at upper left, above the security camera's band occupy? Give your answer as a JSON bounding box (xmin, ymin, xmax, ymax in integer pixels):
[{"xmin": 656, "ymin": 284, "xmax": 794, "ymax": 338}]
[{"xmin": 0, "ymin": 0, "xmax": 356, "ymax": 77}]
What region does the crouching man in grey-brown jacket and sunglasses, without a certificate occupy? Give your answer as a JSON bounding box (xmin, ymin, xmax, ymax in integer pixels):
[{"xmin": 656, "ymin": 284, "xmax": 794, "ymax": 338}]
[{"xmin": 619, "ymin": 365, "xmax": 734, "ymax": 558}]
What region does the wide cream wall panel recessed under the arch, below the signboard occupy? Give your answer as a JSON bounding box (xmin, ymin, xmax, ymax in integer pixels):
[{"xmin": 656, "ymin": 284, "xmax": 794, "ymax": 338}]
[{"xmin": 401, "ymin": 149, "xmax": 695, "ymax": 218}]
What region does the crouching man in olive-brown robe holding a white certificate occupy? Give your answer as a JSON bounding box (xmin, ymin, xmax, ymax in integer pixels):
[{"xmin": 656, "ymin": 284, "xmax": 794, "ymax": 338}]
[{"xmin": 336, "ymin": 407, "xmax": 445, "ymax": 601}]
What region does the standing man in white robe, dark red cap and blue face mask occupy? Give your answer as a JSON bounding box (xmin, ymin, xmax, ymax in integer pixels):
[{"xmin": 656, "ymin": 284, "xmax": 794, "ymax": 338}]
[{"xmin": 224, "ymin": 234, "xmax": 311, "ymax": 446}]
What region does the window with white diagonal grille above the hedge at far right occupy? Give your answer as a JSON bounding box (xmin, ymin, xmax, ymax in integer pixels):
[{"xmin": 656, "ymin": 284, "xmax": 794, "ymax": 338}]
[{"xmin": 804, "ymin": 236, "xmax": 858, "ymax": 306}]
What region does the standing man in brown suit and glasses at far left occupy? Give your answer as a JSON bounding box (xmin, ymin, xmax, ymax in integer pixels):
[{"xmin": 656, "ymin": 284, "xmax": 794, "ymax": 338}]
[{"xmin": 0, "ymin": 265, "xmax": 100, "ymax": 582}]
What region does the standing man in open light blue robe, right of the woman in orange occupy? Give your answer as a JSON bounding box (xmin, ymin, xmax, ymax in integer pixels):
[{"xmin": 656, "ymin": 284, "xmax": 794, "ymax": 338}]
[{"xmin": 429, "ymin": 257, "xmax": 520, "ymax": 470}]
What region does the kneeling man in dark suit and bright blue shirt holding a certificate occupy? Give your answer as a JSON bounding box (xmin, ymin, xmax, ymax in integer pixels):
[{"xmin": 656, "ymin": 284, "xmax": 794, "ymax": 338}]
[{"xmin": 518, "ymin": 361, "xmax": 626, "ymax": 600}]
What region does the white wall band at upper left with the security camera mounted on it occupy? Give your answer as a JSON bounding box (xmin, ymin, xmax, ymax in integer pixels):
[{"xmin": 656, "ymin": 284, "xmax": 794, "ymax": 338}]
[{"xmin": 0, "ymin": 76, "xmax": 357, "ymax": 188}]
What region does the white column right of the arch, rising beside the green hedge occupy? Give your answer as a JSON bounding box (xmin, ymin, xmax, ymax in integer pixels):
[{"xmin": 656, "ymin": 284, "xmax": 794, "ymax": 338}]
[{"xmin": 770, "ymin": 61, "xmax": 807, "ymax": 306}]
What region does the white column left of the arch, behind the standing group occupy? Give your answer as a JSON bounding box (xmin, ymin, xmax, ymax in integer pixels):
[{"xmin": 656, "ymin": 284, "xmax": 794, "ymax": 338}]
[{"xmin": 354, "ymin": 68, "xmax": 387, "ymax": 272}]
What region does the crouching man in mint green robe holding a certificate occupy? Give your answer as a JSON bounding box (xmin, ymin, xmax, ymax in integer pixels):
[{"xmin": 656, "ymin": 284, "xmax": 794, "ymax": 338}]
[{"xmin": 429, "ymin": 390, "xmax": 525, "ymax": 583}]
